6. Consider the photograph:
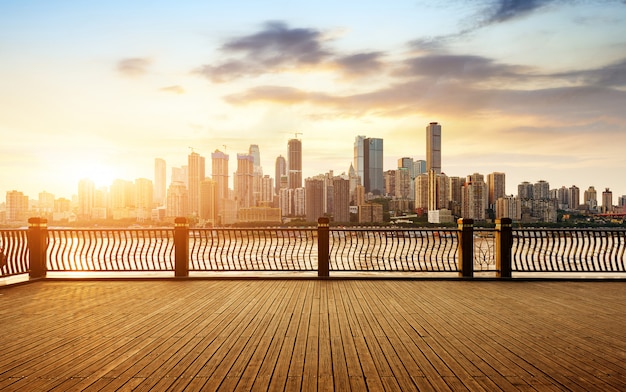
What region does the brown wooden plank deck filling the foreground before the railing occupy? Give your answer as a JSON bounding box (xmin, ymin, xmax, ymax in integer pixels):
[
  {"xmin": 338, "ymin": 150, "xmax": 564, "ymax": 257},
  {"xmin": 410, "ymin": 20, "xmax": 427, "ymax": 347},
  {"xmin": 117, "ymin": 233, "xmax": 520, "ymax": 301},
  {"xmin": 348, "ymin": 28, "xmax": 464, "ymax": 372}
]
[{"xmin": 0, "ymin": 279, "xmax": 626, "ymax": 391}]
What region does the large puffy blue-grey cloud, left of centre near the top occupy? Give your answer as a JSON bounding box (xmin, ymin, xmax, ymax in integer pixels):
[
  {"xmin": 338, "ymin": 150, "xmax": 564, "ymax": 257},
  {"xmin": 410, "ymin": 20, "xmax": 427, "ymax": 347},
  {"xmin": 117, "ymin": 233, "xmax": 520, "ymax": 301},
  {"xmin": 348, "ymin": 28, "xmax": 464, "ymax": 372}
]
[{"xmin": 194, "ymin": 22, "xmax": 331, "ymax": 83}]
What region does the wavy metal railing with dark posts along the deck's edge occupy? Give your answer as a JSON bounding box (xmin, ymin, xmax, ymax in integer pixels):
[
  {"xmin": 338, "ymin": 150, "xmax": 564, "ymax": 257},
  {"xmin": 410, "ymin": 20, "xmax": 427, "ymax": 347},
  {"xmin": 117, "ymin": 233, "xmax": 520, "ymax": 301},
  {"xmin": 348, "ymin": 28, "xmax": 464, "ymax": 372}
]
[{"xmin": 0, "ymin": 218, "xmax": 626, "ymax": 278}]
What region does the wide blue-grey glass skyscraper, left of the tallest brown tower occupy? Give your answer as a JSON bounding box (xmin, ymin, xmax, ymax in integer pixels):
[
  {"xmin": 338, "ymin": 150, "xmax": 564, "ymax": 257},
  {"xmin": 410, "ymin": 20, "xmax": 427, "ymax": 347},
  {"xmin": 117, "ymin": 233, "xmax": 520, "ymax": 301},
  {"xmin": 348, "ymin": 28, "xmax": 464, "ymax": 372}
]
[{"xmin": 354, "ymin": 136, "xmax": 385, "ymax": 195}]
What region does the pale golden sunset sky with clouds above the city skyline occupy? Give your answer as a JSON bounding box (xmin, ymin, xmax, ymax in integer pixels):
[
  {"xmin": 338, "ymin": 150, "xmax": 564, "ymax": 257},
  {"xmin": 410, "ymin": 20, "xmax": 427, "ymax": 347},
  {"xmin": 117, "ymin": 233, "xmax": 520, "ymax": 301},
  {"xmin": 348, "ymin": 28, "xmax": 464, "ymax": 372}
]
[{"xmin": 0, "ymin": 0, "xmax": 626, "ymax": 204}]
